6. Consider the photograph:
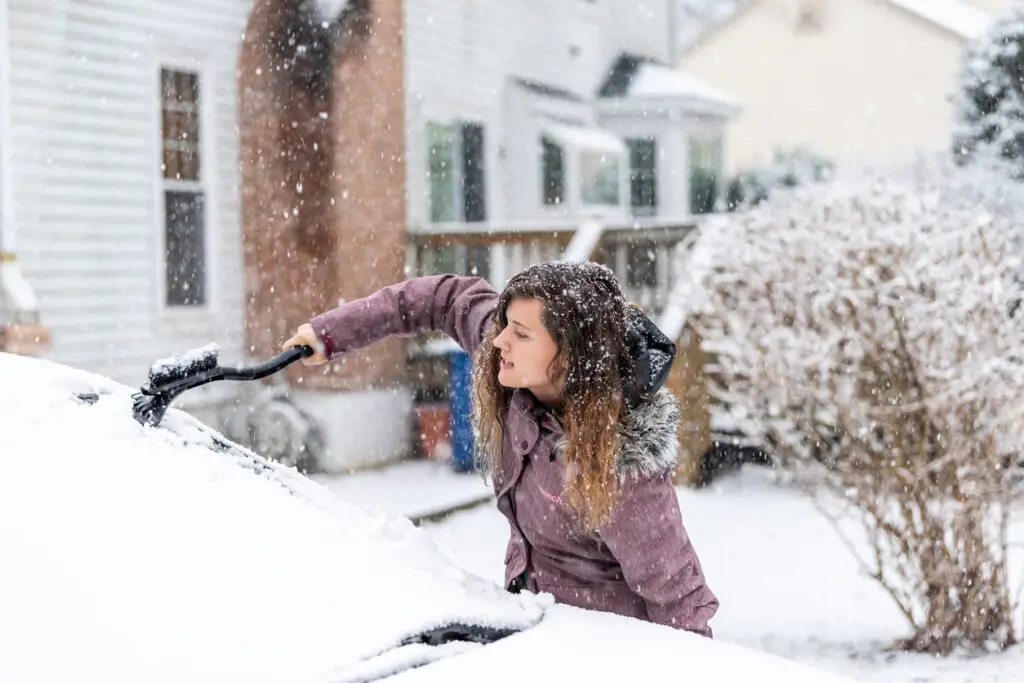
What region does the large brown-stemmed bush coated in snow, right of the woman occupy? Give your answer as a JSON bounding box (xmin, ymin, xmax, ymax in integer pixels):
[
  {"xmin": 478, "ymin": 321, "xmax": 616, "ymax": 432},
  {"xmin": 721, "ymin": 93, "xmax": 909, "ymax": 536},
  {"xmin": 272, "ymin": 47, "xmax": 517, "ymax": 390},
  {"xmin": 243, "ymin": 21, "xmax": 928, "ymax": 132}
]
[{"xmin": 680, "ymin": 157, "xmax": 1024, "ymax": 652}]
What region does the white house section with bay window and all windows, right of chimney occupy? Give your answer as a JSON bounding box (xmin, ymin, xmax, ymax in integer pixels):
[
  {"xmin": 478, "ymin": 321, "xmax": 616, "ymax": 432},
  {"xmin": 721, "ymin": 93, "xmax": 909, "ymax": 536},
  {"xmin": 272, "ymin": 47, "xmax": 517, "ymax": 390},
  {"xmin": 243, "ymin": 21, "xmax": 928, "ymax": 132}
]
[{"xmin": 406, "ymin": 0, "xmax": 739, "ymax": 249}]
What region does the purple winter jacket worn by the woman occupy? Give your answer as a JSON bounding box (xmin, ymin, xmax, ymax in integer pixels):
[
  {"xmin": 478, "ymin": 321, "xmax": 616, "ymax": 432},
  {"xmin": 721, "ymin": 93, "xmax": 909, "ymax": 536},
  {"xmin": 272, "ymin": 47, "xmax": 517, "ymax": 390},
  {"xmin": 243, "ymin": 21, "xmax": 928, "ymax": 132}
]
[{"xmin": 310, "ymin": 274, "xmax": 719, "ymax": 637}]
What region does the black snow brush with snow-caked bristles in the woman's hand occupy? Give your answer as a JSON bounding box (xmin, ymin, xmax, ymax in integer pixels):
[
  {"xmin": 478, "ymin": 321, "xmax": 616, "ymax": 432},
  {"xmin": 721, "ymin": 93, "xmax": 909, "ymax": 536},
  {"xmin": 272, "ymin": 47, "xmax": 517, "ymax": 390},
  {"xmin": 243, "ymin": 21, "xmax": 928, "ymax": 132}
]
[{"xmin": 132, "ymin": 344, "xmax": 313, "ymax": 427}]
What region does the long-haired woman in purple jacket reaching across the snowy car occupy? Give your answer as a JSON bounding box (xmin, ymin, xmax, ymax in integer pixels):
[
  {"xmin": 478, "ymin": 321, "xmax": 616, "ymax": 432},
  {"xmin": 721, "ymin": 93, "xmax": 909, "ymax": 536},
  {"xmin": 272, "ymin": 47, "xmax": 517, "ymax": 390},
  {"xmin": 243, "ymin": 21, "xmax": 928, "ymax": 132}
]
[{"xmin": 284, "ymin": 263, "xmax": 718, "ymax": 637}]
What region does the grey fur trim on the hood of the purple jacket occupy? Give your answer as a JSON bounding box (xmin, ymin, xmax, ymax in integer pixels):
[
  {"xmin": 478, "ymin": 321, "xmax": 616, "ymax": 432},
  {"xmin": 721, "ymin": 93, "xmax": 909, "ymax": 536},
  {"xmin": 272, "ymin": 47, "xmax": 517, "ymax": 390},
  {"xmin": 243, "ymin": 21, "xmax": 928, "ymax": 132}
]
[{"xmin": 555, "ymin": 387, "xmax": 680, "ymax": 481}]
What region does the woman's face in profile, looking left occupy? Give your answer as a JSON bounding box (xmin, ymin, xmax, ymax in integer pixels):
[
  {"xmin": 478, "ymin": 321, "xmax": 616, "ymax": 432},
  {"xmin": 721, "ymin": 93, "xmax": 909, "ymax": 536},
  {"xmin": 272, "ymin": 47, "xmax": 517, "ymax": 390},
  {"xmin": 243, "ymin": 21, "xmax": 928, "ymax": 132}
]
[{"xmin": 494, "ymin": 299, "xmax": 565, "ymax": 404}]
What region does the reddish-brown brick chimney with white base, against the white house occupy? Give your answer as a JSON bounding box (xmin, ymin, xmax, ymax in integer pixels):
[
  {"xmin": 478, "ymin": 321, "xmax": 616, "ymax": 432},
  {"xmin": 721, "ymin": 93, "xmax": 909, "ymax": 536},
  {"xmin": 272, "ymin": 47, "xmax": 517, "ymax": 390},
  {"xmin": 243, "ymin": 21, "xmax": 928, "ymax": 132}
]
[{"xmin": 239, "ymin": 0, "xmax": 412, "ymax": 469}]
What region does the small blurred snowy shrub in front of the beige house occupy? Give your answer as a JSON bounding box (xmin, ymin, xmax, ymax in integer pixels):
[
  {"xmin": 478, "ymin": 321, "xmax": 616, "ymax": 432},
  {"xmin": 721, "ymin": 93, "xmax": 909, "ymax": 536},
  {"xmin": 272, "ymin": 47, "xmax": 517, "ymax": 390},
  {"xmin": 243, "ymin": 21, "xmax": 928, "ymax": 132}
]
[{"xmin": 726, "ymin": 148, "xmax": 835, "ymax": 211}]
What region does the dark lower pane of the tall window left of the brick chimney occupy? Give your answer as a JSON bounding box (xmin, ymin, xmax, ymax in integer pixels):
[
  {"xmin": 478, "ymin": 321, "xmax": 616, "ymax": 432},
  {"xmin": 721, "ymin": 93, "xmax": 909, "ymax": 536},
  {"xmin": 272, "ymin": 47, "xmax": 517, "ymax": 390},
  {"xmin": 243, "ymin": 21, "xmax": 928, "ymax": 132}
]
[{"xmin": 164, "ymin": 190, "xmax": 206, "ymax": 306}]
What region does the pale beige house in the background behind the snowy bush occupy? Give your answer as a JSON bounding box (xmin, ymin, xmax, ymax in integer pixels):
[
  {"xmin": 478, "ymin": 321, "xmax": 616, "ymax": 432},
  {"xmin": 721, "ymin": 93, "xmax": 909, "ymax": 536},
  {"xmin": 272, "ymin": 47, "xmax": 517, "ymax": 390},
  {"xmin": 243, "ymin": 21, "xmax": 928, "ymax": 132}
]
[{"xmin": 679, "ymin": 0, "xmax": 1009, "ymax": 173}]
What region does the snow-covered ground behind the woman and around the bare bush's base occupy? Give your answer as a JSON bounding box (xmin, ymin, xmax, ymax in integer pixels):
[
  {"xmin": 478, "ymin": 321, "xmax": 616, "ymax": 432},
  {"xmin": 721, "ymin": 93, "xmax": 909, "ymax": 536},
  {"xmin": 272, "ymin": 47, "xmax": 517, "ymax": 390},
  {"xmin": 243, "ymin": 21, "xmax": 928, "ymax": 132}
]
[{"xmin": 425, "ymin": 468, "xmax": 1024, "ymax": 683}]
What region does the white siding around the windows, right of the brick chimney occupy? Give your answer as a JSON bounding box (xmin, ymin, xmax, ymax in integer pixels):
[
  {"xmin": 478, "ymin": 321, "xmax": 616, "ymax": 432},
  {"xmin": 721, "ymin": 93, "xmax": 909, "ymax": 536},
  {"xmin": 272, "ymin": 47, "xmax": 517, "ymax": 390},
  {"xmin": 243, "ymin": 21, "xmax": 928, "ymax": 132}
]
[{"xmin": 404, "ymin": 0, "xmax": 668, "ymax": 228}]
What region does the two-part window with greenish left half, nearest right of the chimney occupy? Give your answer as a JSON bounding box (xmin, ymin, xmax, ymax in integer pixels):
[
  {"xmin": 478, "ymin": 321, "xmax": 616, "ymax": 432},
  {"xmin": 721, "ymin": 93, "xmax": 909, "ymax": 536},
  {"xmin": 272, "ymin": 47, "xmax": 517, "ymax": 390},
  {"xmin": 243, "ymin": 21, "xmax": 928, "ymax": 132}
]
[{"xmin": 427, "ymin": 122, "xmax": 487, "ymax": 223}]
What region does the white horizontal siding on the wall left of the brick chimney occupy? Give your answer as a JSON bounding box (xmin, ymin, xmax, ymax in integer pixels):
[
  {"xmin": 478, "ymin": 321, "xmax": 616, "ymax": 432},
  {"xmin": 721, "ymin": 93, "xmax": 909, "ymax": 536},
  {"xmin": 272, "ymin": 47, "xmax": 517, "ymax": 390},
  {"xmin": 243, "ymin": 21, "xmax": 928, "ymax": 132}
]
[{"xmin": 9, "ymin": 0, "xmax": 251, "ymax": 395}]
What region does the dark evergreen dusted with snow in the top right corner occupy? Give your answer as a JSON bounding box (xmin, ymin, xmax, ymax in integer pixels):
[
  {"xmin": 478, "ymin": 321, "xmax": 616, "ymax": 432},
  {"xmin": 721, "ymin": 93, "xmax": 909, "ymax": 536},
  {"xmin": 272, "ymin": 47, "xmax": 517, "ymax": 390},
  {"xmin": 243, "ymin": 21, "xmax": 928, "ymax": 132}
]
[{"xmin": 953, "ymin": 0, "xmax": 1024, "ymax": 179}]
